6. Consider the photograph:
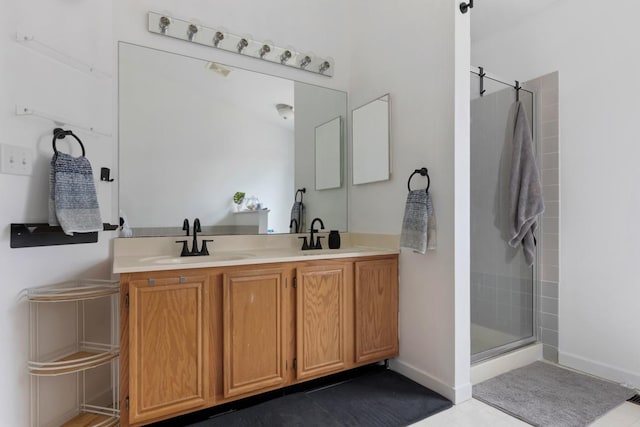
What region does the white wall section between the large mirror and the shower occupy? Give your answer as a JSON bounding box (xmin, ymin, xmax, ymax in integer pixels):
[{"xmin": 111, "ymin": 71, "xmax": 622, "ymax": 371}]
[{"xmin": 349, "ymin": 0, "xmax": 470, "ymax": 400}]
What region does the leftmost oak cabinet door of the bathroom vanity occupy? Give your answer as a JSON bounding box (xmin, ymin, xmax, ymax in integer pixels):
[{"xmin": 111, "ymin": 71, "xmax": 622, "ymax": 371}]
[{"xmin": 129, "ymin": 276, "xmax": 208, "ymax": 423}]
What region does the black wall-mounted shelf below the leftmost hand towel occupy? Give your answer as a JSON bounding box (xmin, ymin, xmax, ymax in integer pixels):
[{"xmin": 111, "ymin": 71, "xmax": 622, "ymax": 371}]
[{"xmin": 10, "ymin": 223, "xmax": 118, "ymax": 248}]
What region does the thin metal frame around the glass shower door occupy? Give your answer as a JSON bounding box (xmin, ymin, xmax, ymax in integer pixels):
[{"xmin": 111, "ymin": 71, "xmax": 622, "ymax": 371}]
[{"xmin": 469, "ymin": 66, "xmax": 542, "ymax": 365}]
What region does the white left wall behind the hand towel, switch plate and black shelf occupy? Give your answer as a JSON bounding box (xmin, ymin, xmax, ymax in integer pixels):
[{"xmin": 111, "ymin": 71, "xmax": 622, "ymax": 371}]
[{"xmin": 0, "ymin": 0, "xmax": 117, "ymax": 426}]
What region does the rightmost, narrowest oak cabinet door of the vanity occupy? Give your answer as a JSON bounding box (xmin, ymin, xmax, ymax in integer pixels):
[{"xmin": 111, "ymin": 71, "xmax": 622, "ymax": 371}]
[{"xmin": 355, "ymin": 258, "xmax": 398, "ymax": 363}]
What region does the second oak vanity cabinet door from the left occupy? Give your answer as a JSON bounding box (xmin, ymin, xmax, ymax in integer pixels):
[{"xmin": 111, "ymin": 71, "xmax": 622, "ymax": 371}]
[{"xmin": 223, "ymin": 269, "xmax": 286, "ymax": 397}]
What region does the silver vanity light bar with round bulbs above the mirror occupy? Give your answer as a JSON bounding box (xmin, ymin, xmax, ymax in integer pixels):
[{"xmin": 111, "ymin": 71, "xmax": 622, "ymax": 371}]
[{"xmin": 149, "ymin": 12, "xmax": 334, "ymax": 77}]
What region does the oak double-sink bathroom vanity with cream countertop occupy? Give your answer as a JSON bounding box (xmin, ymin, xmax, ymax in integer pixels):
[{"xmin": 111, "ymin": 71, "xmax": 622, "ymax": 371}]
[{"xmin": 114, "ymin": 236, "xmax": 398, "ymax": 426}]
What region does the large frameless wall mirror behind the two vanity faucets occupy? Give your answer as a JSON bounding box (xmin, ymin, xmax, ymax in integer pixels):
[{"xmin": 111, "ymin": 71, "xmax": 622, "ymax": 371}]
[{"xmin": 118, "ymin": 42, "xmax": 347, "ymax": 236}]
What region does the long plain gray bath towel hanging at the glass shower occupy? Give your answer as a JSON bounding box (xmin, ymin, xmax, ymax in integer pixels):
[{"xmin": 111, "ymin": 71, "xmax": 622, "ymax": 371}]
[{"xmin": 509, "ymin": 101, "xmax": 544, "ymax": 265}]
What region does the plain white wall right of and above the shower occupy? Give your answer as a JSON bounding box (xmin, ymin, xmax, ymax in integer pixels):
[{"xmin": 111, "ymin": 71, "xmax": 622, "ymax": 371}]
[{"xmin": 472, "ymin": 0, "xmax": 640, "ymax": 386}]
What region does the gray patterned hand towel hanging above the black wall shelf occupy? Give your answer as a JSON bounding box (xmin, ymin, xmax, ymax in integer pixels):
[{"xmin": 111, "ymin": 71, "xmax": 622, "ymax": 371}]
[{"xmin": 49, "ymin": 152, "xmax": 102, "ymax": 235}]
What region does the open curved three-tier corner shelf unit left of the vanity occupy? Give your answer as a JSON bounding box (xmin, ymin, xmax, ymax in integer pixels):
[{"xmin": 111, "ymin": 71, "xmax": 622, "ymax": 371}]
[{"xmin": 26, "ymin": 280, "xmax": 120, "ymax": 427}]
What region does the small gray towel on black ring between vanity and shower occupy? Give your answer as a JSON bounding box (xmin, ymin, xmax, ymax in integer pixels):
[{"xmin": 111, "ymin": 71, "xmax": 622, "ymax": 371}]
[{"xmin": 400, "ymin": 190, "xmax": 436, "ymax": 254}]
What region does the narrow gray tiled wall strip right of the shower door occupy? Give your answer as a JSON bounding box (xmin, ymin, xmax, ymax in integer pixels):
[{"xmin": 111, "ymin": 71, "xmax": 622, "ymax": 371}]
[{"xmin": 525, "ymin": 72, "xmax": 560, "ymax": 362}]
